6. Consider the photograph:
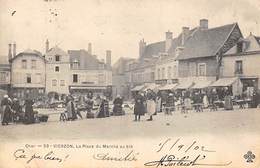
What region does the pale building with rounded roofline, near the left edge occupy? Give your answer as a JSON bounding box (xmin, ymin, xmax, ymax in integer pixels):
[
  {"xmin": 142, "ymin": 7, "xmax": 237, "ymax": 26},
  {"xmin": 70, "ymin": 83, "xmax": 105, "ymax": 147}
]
[{"xmin": 10, "ymin": 49, "xmax": 46, "ymax": 98}]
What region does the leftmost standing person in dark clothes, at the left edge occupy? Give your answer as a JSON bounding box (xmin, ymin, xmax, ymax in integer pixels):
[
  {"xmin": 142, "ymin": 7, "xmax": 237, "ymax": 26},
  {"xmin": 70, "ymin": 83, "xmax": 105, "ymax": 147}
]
[{"xmin": 1, "ymin": 95, "xmax": 12, "ymax": 125}]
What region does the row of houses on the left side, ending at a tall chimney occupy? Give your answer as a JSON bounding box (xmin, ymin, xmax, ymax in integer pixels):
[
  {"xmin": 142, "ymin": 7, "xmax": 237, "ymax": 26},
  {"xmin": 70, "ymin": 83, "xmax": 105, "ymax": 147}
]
[{"xmin": 0, "ymin": 40, "xmax": 112, "ymax": 98}]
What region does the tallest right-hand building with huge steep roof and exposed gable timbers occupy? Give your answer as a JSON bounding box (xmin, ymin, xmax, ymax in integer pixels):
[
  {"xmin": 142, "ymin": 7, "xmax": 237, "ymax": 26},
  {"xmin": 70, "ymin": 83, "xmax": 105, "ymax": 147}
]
[{"xmin": 176, "ymin": 19, "xmax": 243, "ymax": 89}]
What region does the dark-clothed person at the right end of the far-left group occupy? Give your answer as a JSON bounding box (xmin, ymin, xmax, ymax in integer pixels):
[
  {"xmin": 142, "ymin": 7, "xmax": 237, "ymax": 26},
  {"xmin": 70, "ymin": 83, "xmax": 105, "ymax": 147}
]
[{"xmin": 24, "ymin": 95, "xmax": 34, "ymax": 124}]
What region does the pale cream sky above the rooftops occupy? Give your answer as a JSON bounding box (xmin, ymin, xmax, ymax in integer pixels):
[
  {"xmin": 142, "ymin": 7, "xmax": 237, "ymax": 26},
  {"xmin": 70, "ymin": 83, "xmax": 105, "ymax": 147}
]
[{"xmin": 0, "ymin": 0, "xmax": 260, "ymax": 62}]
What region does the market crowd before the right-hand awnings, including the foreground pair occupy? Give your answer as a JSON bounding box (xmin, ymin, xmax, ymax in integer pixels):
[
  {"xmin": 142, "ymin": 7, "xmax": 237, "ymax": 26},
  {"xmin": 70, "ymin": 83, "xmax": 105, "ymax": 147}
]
[{"xmin": 134, "ymin": 88, "xmax": 260, "ymax": 121}]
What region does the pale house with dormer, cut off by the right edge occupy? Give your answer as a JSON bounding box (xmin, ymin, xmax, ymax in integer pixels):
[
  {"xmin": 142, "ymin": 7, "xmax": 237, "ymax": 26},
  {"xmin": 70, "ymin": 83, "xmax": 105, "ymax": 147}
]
[{"xmin": 220, "ymin": 34, "xmax": 260, "ymax": 91}]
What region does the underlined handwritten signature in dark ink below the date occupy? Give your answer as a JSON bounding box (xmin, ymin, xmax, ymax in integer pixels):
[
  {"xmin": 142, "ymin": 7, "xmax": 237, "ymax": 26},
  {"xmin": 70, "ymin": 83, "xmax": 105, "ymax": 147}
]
[{"xmin": 144, "ymin": 155, "xmax": 232, "ymax": 167}]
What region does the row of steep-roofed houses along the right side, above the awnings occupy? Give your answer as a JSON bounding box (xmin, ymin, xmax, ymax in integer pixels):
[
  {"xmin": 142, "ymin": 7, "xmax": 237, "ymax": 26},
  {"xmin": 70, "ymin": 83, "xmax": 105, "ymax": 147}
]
[{"xmin": 113, "ymin": 19, "xmax": 260, "ymax": 96}]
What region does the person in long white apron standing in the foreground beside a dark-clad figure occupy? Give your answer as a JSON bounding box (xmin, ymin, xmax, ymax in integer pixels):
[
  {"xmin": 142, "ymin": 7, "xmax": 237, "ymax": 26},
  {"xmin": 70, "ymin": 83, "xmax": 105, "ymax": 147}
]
[{"xmin": 146, "ymin": 89, "xmax": 156, "ymax": 121}]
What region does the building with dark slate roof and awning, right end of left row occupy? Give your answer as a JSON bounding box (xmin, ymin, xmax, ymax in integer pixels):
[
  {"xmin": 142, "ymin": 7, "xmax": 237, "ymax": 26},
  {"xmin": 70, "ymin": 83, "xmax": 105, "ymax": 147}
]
[{"xmin": 68, "ymin": 47, "xmax": 112, "ymax": 97}]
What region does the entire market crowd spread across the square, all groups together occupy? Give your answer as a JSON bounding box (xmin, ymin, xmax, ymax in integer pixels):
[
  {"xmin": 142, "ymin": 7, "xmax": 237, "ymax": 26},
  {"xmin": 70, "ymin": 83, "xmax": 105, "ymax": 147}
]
[{"xmin": 1, "ymin": 86, "xmax": 260, "ymax": 125}]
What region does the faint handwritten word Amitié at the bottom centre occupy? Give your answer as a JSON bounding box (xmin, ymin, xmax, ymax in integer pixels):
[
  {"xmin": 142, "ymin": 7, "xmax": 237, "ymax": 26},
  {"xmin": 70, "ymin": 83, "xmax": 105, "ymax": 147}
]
[{"xmin": 93, "ymin": 150, "xmax": 139, "ymax": 162}]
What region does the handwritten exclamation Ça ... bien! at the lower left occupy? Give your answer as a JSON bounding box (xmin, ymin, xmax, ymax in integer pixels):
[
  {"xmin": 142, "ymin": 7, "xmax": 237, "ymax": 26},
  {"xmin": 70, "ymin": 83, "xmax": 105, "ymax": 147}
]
[{"xmin": 13, "ymin": 149, "xmax": 69, "ymax": 164}]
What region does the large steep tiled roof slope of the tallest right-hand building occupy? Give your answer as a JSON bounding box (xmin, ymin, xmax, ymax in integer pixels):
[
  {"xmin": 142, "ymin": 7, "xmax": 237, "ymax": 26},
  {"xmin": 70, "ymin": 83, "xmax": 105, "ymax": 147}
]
[{"xmin": 177, "ymin": 23, "xmax": 237, "ymax": 60}]
